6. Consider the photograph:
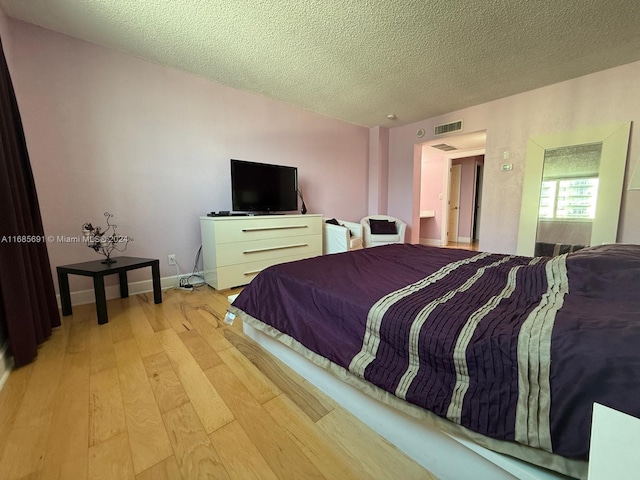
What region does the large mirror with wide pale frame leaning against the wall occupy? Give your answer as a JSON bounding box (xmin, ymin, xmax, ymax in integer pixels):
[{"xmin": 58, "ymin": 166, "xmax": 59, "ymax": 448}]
[{"xmin": 517, "ymin": 122, "xmax": 631, "ymax": 256}]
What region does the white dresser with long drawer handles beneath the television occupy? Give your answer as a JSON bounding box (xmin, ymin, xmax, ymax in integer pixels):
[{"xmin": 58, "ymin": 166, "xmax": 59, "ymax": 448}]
[{"xmin": 200, "ymin": 215, "xmax": 322, "ymax": 290}]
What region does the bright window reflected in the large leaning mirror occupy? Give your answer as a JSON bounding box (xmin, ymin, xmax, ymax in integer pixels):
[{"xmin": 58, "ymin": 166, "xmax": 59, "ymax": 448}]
[{"xmin": 538, "ymin": 178, "xmax": 598, "ymax": 220}]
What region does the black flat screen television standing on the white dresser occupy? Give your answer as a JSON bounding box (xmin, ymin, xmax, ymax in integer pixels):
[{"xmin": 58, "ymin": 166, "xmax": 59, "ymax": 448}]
[{"xmin": 231, "ymin": 159, "xmax": 298, "ymax": 213}]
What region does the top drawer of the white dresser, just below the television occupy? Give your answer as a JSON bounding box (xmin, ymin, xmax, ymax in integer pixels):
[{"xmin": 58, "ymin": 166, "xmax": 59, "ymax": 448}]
[{"xmin": 215, "ymin": 215, "xmax": 322, "ymax": 244}]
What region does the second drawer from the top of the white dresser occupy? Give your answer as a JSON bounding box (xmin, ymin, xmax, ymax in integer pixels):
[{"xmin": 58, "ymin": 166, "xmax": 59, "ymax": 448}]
[{"xmin": 216, "ymin": 235, "xmax": 322, "ymax": 267}]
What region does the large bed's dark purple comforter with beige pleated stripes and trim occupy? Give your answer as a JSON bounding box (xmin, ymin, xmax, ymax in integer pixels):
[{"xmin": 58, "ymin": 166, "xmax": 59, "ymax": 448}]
[{"xmin": 229, "ymin": 244, "xmax": 640, "ymax": 478}]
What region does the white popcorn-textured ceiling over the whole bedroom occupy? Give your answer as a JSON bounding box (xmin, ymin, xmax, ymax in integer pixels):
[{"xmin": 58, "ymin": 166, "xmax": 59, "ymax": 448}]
[{"xmin": 0, "ymin": 0, "xmax": 640, "ymax": 127}]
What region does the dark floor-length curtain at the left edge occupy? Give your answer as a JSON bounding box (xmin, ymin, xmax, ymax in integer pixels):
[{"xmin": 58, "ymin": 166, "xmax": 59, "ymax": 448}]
[{"xmin": 0, "ymin": 34, "xmax": 60, "ymax": 366}]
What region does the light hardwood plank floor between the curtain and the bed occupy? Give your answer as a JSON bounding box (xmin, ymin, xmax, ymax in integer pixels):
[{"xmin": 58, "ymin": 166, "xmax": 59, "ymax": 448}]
[{"xmin": 0, "ymin": 286, "xmax": 435, "ymax": 480}]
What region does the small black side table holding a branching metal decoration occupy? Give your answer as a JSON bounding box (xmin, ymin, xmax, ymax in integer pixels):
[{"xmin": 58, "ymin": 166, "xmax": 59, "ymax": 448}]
[{"xmin": 56, "ymin": 257, "xmax": 162, "ymax": 324}]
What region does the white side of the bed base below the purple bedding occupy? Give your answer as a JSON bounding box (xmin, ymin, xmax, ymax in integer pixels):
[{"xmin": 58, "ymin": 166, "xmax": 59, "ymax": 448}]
[{"xmin": 243, "ymin": 321, "xmax": 570, "ymax": 480}]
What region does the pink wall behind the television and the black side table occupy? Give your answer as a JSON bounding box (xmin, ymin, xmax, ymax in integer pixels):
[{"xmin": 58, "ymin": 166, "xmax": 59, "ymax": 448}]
[{"xmin": 2, "ymin": 19, "xmax": 369, "ymax": 291}]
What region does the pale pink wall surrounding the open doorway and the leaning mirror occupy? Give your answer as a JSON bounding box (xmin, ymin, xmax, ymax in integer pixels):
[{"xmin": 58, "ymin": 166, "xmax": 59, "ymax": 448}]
[{"xmin": 388, "ymin": 62, "xmax": 640, "ymax": 253}]
